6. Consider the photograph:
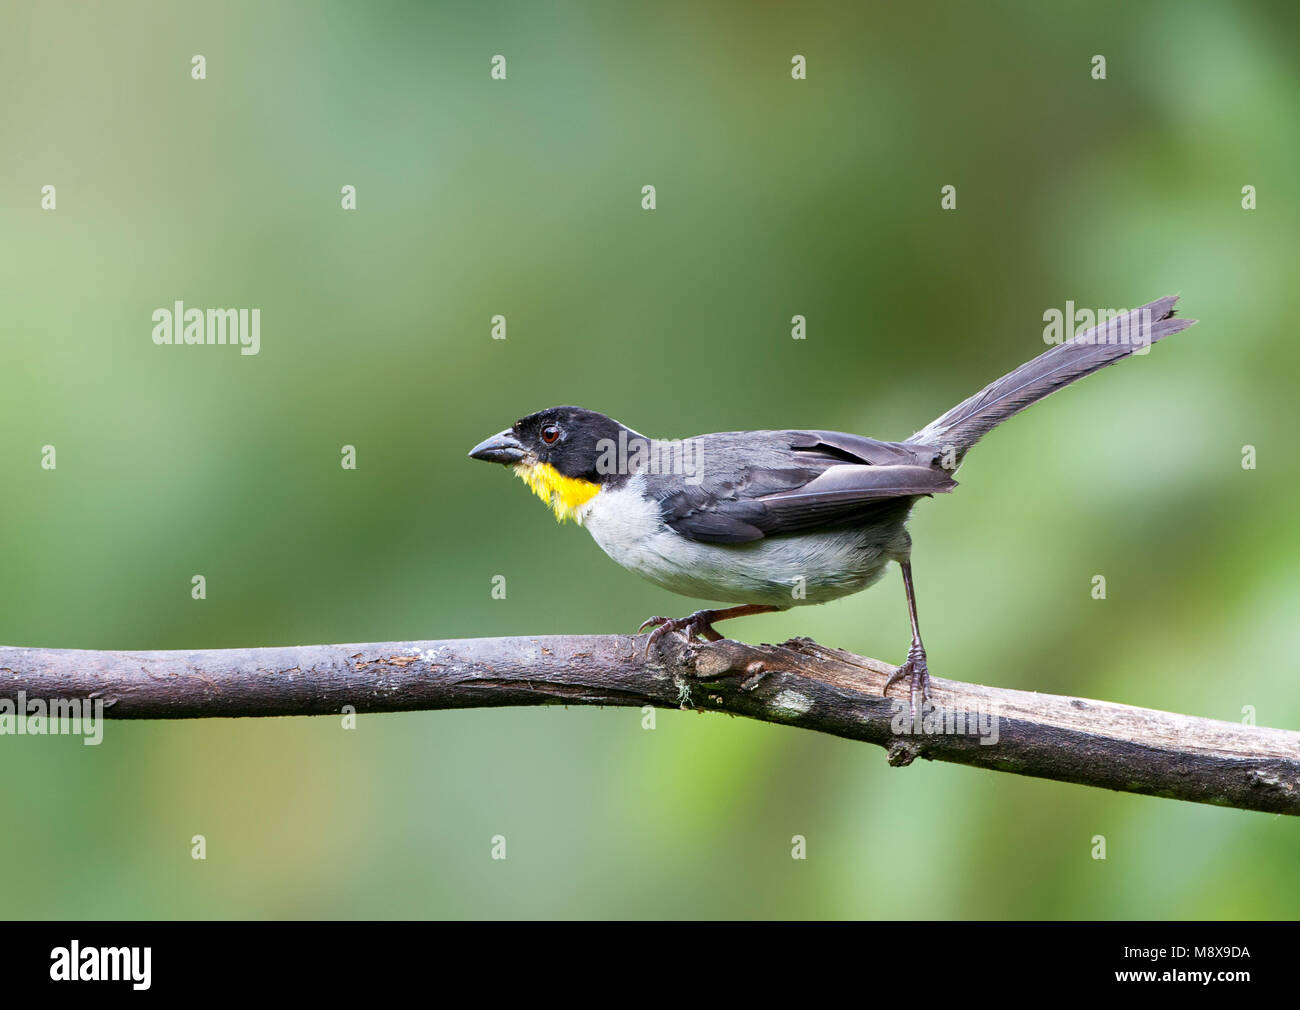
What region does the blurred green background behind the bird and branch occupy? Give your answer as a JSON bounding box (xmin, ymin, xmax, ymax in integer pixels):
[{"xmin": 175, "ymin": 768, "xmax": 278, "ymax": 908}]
[{"xmin": 0, "ymin": 0, "xmax": 1300, "ymax": 918}]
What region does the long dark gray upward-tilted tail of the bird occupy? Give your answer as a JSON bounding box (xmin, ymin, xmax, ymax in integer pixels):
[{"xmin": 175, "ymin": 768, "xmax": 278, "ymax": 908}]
[{"xmin": 907, "ymin": 295, "xmax": 1196, "ymax": 459}]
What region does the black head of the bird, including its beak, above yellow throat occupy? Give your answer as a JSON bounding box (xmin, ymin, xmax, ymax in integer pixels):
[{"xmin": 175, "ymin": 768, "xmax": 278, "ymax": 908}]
[{"xmin": 469, "ymin": 407, "xmax": 641, "ymax": 484}]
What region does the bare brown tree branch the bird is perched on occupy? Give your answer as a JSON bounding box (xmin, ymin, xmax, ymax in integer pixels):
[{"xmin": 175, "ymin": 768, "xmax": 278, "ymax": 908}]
[{"xmin": 0, "ymin": 636, "xmax": 1300, "ymax": 814}]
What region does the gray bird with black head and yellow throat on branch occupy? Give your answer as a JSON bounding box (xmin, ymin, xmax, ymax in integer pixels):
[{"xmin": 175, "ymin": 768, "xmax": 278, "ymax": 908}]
[{"xmin": 469, "ymin": 295, "xmax": 1196, "ymax": 719}]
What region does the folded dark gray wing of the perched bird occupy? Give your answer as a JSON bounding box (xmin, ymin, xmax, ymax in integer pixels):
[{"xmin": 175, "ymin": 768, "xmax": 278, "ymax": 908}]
[{"xmin": 647, "ymin": 432, "xmax": 957, "ymax": 543}]
